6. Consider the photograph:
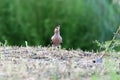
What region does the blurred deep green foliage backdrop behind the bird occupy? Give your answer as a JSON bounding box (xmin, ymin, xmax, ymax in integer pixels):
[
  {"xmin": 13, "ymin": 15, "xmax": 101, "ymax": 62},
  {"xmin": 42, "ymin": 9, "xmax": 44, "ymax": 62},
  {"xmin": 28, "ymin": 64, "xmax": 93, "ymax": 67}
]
[{"xmin": 0, "ymin": 0, "xmax": 120, "ymax": 50}]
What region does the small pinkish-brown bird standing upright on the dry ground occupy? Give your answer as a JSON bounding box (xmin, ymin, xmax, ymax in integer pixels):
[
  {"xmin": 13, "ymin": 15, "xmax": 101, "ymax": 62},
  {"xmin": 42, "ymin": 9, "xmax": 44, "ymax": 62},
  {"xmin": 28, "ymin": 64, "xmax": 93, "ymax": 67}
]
[{"xmin": 51, "ymin": 25, "xmax": 62, "ymax": 48}]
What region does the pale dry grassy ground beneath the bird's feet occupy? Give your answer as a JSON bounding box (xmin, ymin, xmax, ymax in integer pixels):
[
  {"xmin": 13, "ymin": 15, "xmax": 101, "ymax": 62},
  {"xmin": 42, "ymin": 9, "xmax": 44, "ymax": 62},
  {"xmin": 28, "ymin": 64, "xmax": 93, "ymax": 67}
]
[{"xmin": 0, "ymin": 46, "xmax": 120, "ymax": 80}]
